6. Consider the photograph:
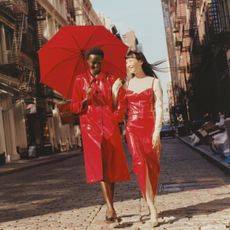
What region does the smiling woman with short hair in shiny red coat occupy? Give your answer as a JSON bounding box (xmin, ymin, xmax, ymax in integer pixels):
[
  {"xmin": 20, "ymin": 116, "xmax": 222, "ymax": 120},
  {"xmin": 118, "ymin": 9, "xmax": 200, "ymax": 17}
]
[{"xmin": 71, "ymin": 48, "xmax": 130, "ymax": 221}]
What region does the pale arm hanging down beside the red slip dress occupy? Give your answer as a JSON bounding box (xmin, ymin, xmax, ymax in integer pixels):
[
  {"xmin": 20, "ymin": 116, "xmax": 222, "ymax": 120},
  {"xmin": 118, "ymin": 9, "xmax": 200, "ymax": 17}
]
[{"xmin": 152, "ymin": 79, "xmax": 163, "ymax": 146}]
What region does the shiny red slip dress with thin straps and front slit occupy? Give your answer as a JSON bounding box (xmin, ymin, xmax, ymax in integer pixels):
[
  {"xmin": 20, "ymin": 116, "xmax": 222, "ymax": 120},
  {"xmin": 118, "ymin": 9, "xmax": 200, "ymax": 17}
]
[{"xmin": 126, "ymin": 80, "xmax": 160, "ymax": 198}]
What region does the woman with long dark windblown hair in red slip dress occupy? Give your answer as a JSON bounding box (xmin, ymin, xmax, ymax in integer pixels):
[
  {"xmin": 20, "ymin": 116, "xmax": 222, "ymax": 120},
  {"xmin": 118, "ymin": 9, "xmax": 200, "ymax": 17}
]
[{"xmin": 113, "ymin": 51, "xmax": 163, "ymax": 226}]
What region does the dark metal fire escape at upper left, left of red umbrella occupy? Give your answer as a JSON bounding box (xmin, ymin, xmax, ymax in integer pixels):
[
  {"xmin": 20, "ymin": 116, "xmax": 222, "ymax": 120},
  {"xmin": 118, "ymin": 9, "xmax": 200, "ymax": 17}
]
[{"xmin": 0, "ymin": 0, "xmax": 34, "ymax": 95}]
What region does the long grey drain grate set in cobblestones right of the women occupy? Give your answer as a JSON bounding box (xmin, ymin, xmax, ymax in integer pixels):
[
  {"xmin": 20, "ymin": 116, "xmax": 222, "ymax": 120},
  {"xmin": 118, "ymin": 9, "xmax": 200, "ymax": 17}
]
[{"xmin": 158, "ymin": 180, "xmax": 224, "ymax": 193}]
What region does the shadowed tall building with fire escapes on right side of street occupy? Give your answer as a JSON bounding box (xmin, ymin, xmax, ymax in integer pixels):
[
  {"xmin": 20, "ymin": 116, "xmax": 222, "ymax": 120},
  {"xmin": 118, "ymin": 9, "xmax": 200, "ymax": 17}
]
[{"xmin": 162, "ymin": 0, "xmax": 230, "ymax": 127}]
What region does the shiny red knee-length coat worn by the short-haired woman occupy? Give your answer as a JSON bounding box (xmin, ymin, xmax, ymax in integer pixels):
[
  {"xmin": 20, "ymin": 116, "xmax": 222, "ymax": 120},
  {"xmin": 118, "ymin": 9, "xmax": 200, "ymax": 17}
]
[{"xmin": 71, "ymin": 72, "xmax": 129, "ymax": 183}]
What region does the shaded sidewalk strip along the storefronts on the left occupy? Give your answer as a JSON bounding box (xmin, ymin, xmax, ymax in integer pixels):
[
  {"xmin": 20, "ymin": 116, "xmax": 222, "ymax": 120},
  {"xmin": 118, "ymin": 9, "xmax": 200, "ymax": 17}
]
[{"xmin": 0, "ymin": 149, "xmax": 82, "ymax": 176}]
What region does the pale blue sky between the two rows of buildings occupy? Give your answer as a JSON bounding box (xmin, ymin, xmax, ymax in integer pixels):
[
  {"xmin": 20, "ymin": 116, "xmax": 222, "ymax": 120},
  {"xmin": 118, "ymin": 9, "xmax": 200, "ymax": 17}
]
[{"xmin": 91, "ymin": 0, "xmax": 170, "ymax": 103}]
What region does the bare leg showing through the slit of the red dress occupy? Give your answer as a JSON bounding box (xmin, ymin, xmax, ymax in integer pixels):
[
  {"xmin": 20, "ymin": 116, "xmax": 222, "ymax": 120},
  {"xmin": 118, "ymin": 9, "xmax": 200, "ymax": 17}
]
[{"xmin": 146, "ymin": 167, "xmax": 158, "ymax": 226}]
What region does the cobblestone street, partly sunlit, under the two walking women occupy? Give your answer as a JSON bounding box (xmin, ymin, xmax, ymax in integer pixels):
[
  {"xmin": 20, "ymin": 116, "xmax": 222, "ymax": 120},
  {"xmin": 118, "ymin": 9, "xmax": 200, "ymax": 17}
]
[{"xmin": 0, "ymin": 139, "xmax": 230, "ymax": 230}]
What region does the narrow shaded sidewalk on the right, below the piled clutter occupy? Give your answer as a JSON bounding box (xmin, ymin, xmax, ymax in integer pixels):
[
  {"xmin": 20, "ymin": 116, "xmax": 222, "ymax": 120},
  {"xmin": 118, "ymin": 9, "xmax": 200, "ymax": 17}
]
[{"xmin": 177, "ymin": 136, "xmax": 230, "ymax": 173}]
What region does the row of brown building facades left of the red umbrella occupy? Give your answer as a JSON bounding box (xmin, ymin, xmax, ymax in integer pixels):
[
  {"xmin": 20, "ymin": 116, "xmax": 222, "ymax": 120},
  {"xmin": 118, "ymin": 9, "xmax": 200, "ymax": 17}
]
[{"xmin": 0, "ymin": 0, "xmax": 101, "ymax": 161}]
